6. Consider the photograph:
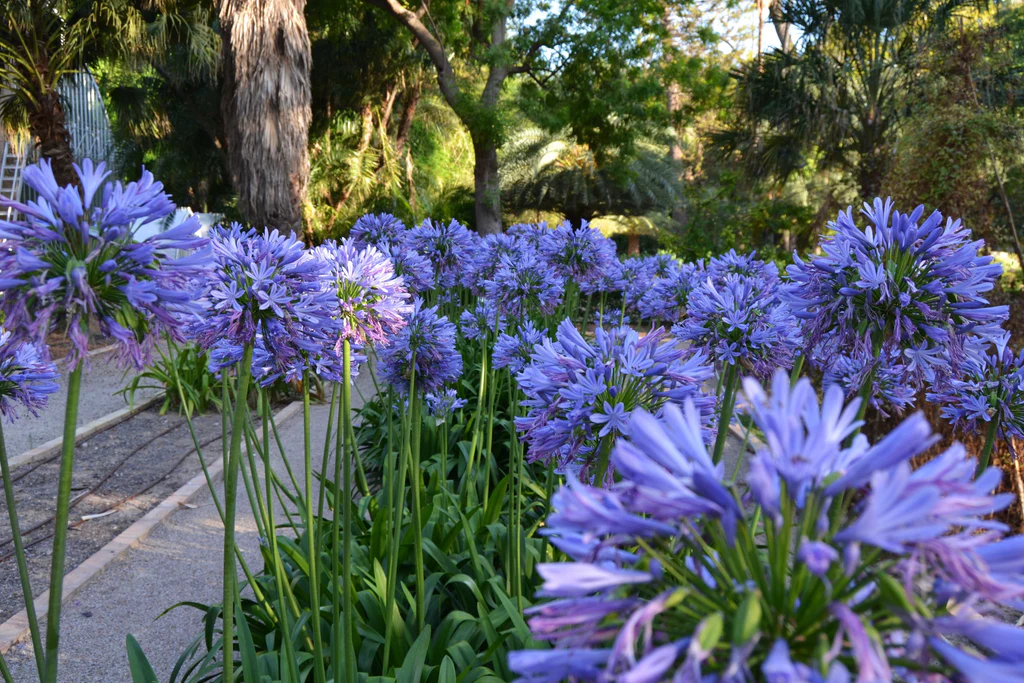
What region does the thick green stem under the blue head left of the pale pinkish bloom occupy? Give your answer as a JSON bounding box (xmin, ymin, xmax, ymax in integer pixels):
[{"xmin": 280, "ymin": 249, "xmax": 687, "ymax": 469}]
[{"xmin": 218, "ymin": 344, "xmax": 253, "ymax": 683}]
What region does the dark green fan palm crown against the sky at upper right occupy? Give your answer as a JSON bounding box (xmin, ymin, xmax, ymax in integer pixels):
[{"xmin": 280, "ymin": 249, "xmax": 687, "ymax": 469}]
[{"xmin": 718, "ymin": 0, "xmax": 974, "ymax": 198}]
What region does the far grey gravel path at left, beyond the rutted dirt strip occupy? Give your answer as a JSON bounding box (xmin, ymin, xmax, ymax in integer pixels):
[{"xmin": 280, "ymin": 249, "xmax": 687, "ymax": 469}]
[{"xmin": 4, "ymin": 351, "xmax": 158, "ymax": 458}]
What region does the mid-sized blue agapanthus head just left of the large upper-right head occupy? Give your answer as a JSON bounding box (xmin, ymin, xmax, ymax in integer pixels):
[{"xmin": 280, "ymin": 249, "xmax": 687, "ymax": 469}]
[{"xmin": 672, "ymin": 274, "xmax": 803, "ymax": 378}]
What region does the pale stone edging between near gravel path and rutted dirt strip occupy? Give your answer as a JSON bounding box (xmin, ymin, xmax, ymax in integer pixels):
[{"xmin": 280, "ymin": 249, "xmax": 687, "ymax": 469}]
[{"xmin": 0, "ymin": 400, "xmax": 302, "ymax": 654}]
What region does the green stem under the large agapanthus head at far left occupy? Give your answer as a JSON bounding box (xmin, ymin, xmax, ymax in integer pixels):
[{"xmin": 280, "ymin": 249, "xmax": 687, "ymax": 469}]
[{"xmin": 42, "ymin": 364, "xmax": 82, "ymax": 683}]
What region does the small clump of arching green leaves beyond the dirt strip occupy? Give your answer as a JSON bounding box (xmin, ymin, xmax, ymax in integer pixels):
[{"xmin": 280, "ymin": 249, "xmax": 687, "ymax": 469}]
[{"xmin": 121, "ymin": 338, "xmax": 222, "ymax": 417}]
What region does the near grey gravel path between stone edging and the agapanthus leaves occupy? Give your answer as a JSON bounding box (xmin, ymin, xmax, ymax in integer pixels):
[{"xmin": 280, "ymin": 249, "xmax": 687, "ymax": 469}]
[{"xmin": 6, "ymin": 373, "xmax": 373, "ymax": 683}]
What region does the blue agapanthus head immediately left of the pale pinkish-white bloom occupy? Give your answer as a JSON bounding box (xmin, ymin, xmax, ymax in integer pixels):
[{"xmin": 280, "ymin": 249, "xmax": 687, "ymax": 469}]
[{"xmin": 191, "ymin": 223, "xmax": 343, "ymax": 377}]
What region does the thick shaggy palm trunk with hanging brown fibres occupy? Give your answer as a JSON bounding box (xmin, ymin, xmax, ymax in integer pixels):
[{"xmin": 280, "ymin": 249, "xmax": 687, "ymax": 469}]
[{"xmin": 220, "ymin": 0, "xmax": 313, "ymax": 242}]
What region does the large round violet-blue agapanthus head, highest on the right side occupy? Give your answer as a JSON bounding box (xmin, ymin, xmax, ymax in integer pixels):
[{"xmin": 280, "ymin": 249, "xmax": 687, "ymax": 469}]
[{"xmin": 785, "ymin": 199, "xmax": 1007, "ymax": 387}]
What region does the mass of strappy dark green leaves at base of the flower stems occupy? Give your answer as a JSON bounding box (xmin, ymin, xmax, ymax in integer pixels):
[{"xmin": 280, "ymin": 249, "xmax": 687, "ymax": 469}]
[{"xmin": 151, "ymin": 473, "xmax": 544, "ymax": 683}]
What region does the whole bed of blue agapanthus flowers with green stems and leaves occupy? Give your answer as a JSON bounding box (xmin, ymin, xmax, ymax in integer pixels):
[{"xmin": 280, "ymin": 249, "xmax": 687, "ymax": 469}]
[{"xmin": 0, "ymin": 165, "xmax": 1024, "ymax": 683}]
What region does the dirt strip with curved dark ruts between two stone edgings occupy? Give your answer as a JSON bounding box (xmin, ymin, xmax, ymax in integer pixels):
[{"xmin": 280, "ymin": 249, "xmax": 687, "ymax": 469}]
[{"xmin": 0, "ymin": 407, "xmax": 230, "ymax": 622}]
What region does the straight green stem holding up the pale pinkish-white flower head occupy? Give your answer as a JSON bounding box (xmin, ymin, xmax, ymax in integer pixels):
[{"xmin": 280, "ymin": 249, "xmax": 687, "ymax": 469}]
[{"xmin": 334, "ymin": 339, "xmax": 359, "ymax": 683}]
